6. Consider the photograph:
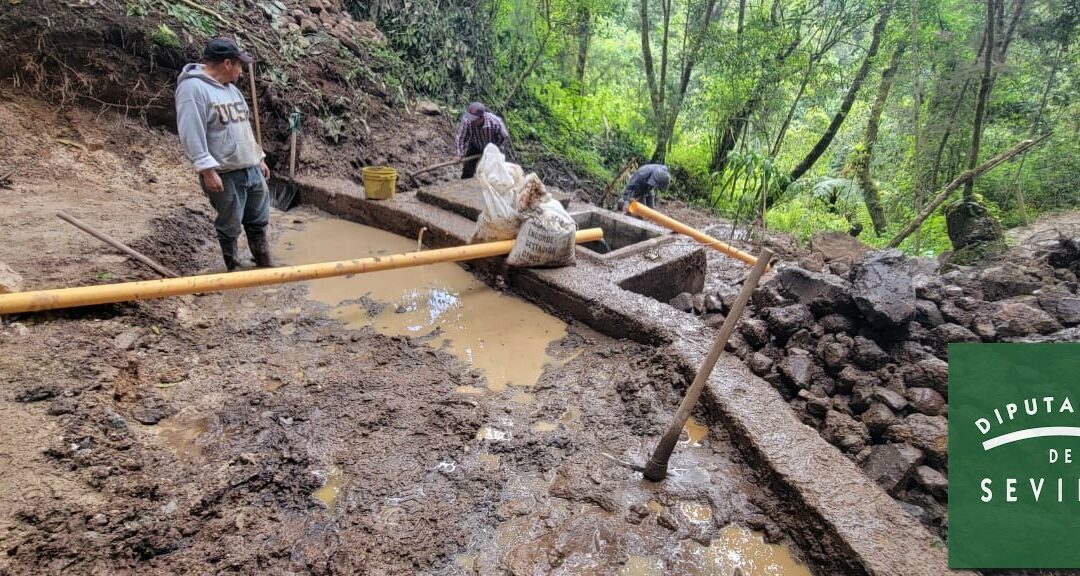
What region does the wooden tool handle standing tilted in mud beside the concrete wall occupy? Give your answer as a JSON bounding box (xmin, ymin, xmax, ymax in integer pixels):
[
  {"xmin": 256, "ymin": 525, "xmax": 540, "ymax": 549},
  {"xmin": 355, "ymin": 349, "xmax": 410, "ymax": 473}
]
[{"xmin": 644, "ymin": 247, "xmax": 772, "ymax": 482}]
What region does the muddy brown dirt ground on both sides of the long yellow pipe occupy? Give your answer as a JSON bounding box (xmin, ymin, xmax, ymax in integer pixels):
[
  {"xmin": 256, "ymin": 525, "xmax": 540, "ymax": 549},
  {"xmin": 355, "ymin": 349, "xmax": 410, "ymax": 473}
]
[{"xmin": 0, "ymin": 91, "xmax": 812, "ymax": 576}]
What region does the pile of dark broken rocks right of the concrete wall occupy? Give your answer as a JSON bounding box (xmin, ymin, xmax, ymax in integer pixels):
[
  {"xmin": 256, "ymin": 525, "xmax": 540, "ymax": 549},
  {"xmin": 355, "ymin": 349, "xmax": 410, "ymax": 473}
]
[{"xmin": 672, "ymin": 230, "xmax": 1080, "ymax": 527}]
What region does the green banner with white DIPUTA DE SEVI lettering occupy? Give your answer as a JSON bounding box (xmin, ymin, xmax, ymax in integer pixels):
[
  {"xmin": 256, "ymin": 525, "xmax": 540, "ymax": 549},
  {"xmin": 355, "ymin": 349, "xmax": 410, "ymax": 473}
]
[{"xmin": 948, "ymin": 344, "xmax": 1080, "ymax": 568}]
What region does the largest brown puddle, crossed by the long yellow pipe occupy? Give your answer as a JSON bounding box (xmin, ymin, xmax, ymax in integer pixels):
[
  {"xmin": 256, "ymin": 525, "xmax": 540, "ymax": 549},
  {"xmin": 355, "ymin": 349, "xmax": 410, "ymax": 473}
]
[{"xmin": 276, "ymin": 219, "xmax": 566, "ymax": 391}]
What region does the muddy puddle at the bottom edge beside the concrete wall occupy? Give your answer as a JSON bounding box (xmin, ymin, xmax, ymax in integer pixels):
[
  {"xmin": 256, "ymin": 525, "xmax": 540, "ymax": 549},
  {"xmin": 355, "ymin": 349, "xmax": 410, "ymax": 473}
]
[{"xmin": 670, "ymin": 525, "xmax": 811, "ymax": 576}]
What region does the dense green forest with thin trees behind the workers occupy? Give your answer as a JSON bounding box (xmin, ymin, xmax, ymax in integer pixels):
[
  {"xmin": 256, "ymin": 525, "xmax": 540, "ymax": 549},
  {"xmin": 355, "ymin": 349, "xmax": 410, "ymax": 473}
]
[{"xmin": 348, "ymin": 0, "xmax": 1080, "ymax": 253}]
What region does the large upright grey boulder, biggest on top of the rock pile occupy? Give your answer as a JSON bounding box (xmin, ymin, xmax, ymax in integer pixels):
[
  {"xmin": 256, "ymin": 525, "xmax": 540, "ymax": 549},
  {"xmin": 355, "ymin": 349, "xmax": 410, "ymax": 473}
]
[{"xmin": 851, "ymin": 250, "xmax": 916, "ymax": 329}]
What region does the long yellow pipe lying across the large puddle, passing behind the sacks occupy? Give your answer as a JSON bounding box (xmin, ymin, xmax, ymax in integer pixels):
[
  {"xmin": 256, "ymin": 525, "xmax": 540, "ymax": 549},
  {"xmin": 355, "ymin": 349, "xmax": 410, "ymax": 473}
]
[{"xmin": 0, "ymin": 228, "xmax": 604, "ymax": 314}]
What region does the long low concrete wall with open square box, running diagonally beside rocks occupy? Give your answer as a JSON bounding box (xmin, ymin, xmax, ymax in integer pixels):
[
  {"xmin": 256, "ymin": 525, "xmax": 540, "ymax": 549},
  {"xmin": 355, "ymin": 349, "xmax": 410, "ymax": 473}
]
[{"xmin": 298, "ymin": 178, "xmax": 970, "ymax": 576}]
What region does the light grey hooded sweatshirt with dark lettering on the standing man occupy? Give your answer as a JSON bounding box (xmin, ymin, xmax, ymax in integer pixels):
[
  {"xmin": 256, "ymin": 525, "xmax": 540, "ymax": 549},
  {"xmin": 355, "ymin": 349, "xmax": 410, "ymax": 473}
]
[{"xmin": 176, "ymin": 64, "xmax": 266, "ymax": 172}]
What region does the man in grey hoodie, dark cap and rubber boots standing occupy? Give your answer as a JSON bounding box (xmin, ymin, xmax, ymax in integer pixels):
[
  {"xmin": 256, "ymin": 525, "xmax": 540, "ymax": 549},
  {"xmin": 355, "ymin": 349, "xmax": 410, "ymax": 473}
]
[{"xmin": 176, "ymin": 38, "xmax": 274, "ymax": 271}]
